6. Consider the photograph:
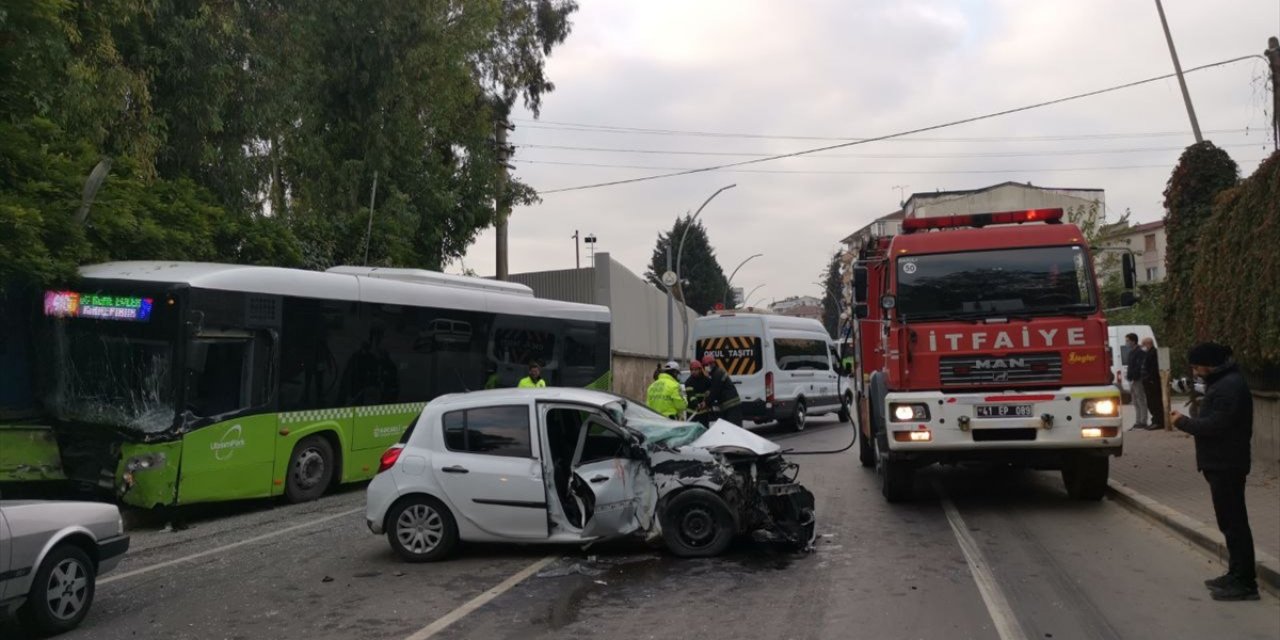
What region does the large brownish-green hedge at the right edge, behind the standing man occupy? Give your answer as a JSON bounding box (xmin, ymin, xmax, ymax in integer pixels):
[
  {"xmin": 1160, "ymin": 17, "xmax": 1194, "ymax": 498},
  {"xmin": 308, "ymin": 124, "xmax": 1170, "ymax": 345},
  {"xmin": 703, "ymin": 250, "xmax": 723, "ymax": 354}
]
[{"xmin": 1187, "ymin": 152, "xmax": 1280, "ymax": 389}]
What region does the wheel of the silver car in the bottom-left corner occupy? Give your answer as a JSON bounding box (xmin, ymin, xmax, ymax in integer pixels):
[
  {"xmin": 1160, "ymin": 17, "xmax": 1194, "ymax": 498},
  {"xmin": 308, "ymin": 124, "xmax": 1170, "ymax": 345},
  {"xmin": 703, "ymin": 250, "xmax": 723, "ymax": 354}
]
[{"xmin": 19, "ymin": 544, "xmax": 97, "ymax": 636}]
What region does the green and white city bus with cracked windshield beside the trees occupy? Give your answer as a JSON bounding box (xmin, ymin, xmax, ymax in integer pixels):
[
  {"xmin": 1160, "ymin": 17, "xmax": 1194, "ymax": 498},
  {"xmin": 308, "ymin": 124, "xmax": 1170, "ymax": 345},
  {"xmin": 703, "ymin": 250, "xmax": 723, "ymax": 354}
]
[{"xmin": 0, "ymin": 262, "xmax": 611, "ymax": 508}]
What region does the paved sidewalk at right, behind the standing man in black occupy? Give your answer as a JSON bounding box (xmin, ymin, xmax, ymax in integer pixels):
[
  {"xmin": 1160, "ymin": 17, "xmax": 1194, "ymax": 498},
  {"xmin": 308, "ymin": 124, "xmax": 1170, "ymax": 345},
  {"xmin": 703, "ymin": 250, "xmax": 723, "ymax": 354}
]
[{"xmin": 1111, "ymin": 417, "xmax": 1280, "ymax": 591}]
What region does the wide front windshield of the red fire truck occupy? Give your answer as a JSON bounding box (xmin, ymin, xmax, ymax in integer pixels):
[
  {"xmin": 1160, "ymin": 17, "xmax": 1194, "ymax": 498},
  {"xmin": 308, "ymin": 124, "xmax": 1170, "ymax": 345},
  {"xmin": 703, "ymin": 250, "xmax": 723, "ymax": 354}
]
[{"xmin": 895, "ymin": 246, "xmax": 1097, "ymax": 321}]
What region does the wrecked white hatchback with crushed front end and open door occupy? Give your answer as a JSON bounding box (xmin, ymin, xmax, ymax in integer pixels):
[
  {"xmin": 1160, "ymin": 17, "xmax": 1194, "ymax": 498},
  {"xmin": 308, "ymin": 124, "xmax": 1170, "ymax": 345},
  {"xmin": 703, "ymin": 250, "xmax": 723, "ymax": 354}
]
[{"xmin": 366, "ymin": 389, "xmax": 814, "ymax": 562}]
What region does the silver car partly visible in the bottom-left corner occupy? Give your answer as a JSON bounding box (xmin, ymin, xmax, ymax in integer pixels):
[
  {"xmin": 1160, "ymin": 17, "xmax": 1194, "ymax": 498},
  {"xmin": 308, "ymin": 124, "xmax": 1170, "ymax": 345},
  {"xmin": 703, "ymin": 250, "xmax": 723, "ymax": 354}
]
[{"xmin": 0, "ymin": 500, "xmax": 129, "ymax": 635}]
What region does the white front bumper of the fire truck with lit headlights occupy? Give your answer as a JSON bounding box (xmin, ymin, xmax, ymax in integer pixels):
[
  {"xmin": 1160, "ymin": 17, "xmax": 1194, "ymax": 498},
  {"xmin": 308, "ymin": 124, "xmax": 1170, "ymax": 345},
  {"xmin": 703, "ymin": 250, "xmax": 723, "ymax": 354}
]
[{"xmin": 881, "ymin": 385, "xmax": 1124, "ymax": 458}]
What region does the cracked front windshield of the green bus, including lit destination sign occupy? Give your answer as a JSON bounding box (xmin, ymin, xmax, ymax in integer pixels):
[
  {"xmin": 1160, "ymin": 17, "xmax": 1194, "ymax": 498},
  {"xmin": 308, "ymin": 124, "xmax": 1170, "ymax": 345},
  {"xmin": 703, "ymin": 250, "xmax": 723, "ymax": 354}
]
[{"xmin": 42, "ymin": 292, "xmax": 174, "ymax": 433}]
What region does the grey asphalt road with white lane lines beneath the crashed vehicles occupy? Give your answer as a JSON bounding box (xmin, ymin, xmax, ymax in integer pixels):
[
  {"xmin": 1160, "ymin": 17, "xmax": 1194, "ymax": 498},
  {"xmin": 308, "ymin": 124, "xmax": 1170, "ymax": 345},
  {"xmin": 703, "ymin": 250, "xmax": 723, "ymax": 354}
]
[{"xmin": 0, "ymin": 419, "xmax": 1280, "ymax": 640}]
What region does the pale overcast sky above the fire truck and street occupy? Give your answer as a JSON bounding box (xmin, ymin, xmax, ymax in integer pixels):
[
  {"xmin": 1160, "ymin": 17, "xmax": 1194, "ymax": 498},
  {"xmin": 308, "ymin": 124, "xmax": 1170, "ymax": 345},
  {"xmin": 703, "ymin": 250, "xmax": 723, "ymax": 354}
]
[{"xmin": 460, "ymin": 0, "xmax": 1280, "ymax": 303}]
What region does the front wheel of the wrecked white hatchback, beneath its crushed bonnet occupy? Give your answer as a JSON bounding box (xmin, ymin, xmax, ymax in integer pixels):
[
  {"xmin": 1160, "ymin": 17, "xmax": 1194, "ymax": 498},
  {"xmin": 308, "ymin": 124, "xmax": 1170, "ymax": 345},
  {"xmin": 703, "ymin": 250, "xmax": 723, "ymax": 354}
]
[{"xmin": 660, "ymin": 489, "xmax": 736, "ymax": 558}]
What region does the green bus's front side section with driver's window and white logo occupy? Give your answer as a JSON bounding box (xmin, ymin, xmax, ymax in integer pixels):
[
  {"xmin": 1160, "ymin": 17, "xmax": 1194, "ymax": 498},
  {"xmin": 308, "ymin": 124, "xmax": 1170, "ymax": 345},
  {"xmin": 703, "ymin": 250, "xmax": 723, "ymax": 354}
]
[{"xmin": 178, "ymin": 330, "xmax": 279, "ymax": 504}]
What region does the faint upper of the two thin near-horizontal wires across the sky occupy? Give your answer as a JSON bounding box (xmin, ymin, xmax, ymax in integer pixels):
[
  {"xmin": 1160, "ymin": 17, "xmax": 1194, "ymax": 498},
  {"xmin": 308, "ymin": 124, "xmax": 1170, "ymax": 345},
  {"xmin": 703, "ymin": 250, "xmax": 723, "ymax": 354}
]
[{"xmin": 513, "ymin": 118, "xmax": 1249, "ymax": 142}]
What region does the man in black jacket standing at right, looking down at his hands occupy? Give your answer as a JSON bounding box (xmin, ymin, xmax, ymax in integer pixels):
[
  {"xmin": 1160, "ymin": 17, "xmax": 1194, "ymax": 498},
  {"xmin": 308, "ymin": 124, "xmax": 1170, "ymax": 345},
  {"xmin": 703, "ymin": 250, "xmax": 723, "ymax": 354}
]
[{"xmin": 1169, "ymin": 342, "xmax": 1258, "ymax": 600}]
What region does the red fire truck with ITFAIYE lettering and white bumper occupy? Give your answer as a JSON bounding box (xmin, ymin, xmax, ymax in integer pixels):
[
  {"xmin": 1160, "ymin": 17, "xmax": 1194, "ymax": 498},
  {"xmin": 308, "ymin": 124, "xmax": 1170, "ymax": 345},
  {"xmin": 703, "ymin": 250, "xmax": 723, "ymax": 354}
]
[{"xmin": 852, "ymin": 209, "xmax": 1132, "ymax": 502}]
